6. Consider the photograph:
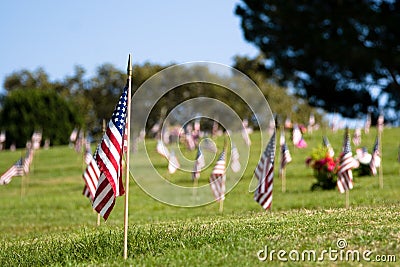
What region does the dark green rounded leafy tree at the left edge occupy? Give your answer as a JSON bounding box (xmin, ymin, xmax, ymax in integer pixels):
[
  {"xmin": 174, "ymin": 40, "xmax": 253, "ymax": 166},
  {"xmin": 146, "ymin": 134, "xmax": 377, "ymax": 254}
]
[{"xmin": 0, "ymin": 89, "xmax": 82, "ymax": 147}]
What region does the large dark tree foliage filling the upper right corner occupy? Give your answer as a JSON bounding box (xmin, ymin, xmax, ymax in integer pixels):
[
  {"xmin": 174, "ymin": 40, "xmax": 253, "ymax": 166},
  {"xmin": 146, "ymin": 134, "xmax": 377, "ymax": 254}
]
[{"xmin": 235, "ymin": 0, "xmax": 400, "ymax": 123}]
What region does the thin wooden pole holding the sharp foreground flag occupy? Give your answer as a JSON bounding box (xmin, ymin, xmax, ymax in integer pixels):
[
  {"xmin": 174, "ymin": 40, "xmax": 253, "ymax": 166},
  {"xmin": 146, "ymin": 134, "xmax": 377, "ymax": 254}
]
[{"xmin": 124, "ymin": 54, "xmax": 132, "ymax": 260}]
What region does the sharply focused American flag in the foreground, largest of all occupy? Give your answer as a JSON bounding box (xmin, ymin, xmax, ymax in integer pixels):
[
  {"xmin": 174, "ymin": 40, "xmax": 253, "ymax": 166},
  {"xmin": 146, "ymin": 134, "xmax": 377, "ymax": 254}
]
[{"xmin": 92, "ymin": 79, "xmax": 129, "ymax": 220}]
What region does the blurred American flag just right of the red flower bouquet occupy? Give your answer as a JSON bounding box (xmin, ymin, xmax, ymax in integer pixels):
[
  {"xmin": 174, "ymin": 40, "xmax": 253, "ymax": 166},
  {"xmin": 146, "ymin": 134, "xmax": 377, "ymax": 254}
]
[{"xmin": 337, "ymin": 129, "xmax": 354, "ymax": 193}]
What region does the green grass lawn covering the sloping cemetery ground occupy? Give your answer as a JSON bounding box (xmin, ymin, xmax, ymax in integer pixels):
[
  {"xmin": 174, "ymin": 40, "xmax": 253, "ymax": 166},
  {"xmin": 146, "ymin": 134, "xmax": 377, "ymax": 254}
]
[{"xmin": 0, "ymin": 129, "xmax": 400, "ymax": 266}]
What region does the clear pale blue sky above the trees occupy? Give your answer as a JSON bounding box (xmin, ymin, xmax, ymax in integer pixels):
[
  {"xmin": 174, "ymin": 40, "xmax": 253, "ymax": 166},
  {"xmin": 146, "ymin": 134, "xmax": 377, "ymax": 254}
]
[{"xmin": 0, "ymin": 0, "xmax": 257, "ymax": 91}]
